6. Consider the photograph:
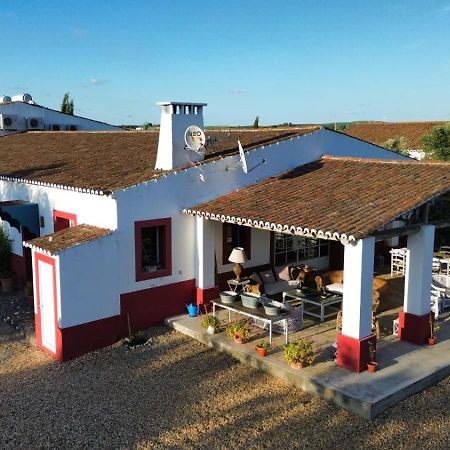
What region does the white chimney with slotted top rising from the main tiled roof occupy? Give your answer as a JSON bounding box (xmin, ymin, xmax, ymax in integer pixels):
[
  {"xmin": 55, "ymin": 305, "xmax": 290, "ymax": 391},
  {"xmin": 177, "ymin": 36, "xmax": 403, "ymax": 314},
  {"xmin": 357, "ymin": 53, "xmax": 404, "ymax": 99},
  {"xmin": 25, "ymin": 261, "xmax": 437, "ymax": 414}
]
[{"xmin": 155, "ymin": 102, "xmax": 206, "ymax": 170}]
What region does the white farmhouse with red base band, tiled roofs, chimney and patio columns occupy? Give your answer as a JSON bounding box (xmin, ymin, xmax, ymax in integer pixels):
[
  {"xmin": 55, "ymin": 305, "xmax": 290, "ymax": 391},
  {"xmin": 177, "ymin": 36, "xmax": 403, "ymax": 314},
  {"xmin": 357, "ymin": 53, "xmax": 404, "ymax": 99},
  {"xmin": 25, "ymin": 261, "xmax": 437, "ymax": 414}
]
[{"xmin": 0, "ymin": 102, "xmax": 450, "ymax": 371}]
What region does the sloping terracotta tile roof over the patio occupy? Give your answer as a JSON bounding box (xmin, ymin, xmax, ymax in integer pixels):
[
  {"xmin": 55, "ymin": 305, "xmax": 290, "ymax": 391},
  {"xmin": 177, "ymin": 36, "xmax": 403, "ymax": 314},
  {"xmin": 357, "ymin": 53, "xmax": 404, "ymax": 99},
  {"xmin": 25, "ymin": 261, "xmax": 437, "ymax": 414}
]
[{"xmin": 183, "ymin": 156, "xmax": 450, "ymax": 240}]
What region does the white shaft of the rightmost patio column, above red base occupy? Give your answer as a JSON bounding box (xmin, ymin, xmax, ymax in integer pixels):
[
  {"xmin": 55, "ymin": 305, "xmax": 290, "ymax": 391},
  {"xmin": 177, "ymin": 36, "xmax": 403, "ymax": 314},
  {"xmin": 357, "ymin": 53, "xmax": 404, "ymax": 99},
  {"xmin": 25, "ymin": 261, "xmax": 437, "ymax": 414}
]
[{"xmin": 404, "ymin": 225, "xmax": 434, "ymax": 316}]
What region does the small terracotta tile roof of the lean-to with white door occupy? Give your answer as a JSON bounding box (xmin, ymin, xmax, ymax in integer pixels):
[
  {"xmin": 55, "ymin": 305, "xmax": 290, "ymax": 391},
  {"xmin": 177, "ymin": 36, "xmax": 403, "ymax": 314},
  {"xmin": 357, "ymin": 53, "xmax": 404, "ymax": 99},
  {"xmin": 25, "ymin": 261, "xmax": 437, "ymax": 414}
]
[{"xmin": 24, "ymin": 224, "xmax": 112, "ymax": 255}]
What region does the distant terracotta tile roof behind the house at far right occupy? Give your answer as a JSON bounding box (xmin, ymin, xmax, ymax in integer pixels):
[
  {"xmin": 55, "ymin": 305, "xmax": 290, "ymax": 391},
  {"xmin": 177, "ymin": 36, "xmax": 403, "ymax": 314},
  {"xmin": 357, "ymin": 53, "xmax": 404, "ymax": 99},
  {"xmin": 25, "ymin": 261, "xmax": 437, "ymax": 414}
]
[{"xmin": 345, "ymin": 122, "xmax": 446, "ymax": 150}]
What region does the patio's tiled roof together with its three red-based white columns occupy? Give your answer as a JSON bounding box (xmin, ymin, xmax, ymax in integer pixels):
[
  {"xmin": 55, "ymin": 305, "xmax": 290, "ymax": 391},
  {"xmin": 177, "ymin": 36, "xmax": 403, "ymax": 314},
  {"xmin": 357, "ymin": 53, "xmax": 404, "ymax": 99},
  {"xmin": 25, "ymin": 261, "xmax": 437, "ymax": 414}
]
[{"xmin": 183, "ymin": 157, "xmax": 450, "ymax": 373}]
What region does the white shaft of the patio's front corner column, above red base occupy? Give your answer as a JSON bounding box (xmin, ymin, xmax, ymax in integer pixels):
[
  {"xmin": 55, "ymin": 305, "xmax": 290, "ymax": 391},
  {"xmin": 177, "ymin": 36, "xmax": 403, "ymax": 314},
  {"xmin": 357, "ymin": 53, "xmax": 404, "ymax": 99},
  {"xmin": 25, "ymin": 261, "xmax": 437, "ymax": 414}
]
[{"xmin": 342, "ymin": 236, "xmax": 375, "ymax": 339}]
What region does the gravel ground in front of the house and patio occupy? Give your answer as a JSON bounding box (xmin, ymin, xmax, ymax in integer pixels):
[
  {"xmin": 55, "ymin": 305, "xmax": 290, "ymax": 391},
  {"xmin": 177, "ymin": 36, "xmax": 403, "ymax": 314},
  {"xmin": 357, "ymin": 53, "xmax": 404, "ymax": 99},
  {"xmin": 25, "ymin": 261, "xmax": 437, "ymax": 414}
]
[{"xmin": 0, "ymin": 324, "xmax": 450, "ymax": 449}]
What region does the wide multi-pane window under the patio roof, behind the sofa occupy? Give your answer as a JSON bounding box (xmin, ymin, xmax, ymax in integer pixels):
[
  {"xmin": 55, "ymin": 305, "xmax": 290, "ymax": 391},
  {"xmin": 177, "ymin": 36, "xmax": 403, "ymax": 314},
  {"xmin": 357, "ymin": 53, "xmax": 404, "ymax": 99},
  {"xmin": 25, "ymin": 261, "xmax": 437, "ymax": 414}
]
[{"xmin": 275, "ymin": 233, "xmax": 329, "ymax": 266}]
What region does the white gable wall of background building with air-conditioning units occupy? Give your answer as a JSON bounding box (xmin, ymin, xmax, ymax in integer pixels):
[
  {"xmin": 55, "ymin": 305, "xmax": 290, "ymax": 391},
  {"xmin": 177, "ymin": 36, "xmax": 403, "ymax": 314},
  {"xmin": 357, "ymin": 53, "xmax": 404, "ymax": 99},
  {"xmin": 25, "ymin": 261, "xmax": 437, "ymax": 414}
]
[{"xmin": 0, "ymin": 102, "xmax": 121, "ymax": 136}]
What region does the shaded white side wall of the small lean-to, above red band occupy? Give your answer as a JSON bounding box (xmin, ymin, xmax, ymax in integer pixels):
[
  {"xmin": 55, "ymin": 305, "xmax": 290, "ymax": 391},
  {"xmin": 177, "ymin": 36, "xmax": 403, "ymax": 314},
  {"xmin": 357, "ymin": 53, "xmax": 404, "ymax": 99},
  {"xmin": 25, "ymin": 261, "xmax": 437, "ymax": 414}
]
[{"xmin": 59, "ymin": 233, "xmax": 120, "ymax": 328}]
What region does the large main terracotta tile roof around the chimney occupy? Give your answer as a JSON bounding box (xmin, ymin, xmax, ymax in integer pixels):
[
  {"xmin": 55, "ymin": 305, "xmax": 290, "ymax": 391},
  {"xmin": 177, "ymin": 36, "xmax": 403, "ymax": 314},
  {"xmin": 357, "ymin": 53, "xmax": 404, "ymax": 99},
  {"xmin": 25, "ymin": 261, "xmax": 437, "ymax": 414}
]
[{"xmin": 0, "ymin": 127, "xmax": 318, "ymax": 192}]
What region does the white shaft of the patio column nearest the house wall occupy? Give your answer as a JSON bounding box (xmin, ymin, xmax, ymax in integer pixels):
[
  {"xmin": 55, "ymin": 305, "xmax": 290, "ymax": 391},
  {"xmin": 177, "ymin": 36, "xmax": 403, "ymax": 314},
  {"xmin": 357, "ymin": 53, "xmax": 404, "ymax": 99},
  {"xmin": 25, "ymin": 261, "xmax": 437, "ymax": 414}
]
[{"xmin": 195, "ymin": 217, "xmax": 215, "ymax": 289}]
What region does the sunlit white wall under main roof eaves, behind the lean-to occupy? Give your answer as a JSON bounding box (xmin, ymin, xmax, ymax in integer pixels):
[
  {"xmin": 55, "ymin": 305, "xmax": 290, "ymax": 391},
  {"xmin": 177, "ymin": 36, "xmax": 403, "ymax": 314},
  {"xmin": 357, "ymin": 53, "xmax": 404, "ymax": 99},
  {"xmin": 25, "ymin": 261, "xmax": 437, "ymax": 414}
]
[{"xmin": 0, "ymin": 180, "xmax": 117, "ymax": 235}]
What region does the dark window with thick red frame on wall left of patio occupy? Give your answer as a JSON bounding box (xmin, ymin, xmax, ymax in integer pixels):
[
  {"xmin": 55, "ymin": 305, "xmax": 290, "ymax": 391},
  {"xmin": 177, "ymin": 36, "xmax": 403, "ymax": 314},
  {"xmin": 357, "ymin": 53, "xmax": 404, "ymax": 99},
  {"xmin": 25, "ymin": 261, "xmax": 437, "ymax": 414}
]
[{"xmin": 135, "ymin": 219, "xmax": 172, "ymax": 281}]
